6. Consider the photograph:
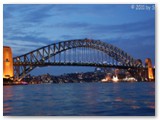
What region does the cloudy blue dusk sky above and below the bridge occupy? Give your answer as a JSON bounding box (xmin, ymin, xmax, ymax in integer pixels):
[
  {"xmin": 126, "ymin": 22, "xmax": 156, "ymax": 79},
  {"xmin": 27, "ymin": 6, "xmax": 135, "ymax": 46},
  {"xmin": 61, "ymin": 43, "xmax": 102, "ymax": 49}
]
[{"xmin": 3, "ymin": 4, "xmax": 155, "ymax": 75}]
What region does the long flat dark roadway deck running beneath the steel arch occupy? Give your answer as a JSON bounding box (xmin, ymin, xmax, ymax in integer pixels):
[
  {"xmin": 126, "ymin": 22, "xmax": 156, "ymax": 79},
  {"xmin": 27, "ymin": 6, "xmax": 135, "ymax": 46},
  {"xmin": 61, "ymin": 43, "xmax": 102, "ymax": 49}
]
[{"xmin": 13, "ymin": 62, "xmax": 147, "ymax": 69}]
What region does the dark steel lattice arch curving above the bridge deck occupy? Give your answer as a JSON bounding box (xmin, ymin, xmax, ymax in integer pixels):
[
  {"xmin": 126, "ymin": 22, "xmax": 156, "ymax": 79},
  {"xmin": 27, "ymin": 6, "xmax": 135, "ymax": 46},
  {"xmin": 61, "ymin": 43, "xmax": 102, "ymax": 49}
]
[{"xmin": 13, "ymin": 39, "xmax": 135, "ymax": 79}]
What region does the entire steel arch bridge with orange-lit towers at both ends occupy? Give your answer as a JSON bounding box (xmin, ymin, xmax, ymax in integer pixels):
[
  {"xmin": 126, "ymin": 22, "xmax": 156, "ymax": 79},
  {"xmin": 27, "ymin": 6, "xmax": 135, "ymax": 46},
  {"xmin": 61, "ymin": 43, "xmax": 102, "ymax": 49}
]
[{"xmin": 3, "ymin": 39, "xmax": 154, "ymax": 80}]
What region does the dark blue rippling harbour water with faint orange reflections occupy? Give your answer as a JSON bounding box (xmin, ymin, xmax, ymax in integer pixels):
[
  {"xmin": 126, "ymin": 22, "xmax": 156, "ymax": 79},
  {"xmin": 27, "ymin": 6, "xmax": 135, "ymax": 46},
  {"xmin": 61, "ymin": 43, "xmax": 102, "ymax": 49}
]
[{"xmin": 3, "ymin": 82, "xmax": 155, "ymax": 116}]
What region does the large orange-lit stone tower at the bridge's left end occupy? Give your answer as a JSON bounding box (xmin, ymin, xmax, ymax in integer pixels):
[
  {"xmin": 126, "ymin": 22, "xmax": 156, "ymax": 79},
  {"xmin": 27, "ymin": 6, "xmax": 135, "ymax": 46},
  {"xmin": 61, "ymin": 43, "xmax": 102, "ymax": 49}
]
[{"xmin": 3, "ymin": 46, "xmax": 14, "ymax": 79}]
